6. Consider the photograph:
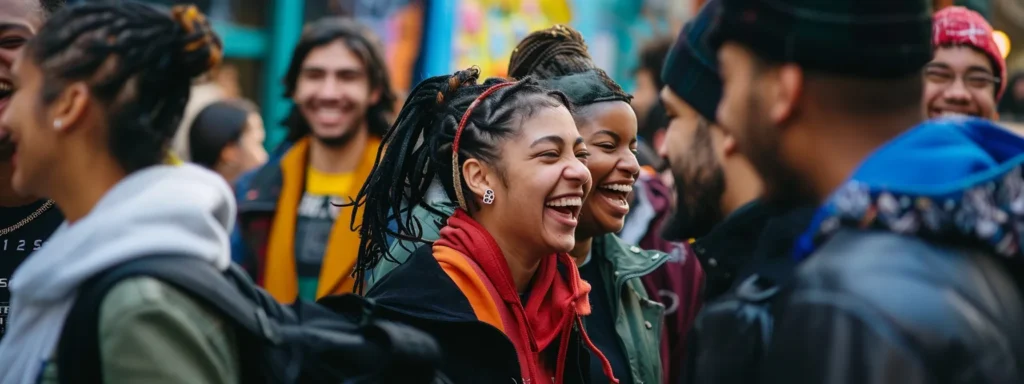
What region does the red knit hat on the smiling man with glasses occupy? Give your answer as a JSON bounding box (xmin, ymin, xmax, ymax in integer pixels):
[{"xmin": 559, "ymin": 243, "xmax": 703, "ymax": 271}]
[{"xmin": 932, "ymin": 6, "xmax": 1007, "ymax": 101}]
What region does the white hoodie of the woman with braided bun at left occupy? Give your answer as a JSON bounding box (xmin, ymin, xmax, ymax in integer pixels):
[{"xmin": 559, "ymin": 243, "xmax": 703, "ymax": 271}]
[{"xmin": 0, "ymin": 165, "xmax": 234, "ymax": 384}]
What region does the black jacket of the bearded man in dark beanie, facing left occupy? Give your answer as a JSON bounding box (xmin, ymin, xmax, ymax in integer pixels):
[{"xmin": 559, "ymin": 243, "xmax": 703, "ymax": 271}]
[{"xmin": 682, "ymin": 202, "xmax": 814, "ymax": 384}]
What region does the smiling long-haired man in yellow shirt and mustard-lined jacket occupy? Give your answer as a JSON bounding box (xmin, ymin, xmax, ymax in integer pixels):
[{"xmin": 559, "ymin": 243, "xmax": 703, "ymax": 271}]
[{"xmin": 232, "ymin": 17, "xmax": 395, "ymax": 303}]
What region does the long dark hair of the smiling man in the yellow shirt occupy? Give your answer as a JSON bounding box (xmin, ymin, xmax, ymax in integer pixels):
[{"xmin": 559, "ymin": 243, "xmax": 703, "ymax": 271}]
[{"xmin": 282, "ymin": 17, "xmax": 397, "ymax": 142}]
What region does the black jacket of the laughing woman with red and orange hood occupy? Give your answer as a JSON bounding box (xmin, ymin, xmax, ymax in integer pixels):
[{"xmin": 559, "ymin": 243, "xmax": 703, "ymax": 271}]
[{"xmin": 335, "ymin": 246, "xmax": 590, "ymax": 384}]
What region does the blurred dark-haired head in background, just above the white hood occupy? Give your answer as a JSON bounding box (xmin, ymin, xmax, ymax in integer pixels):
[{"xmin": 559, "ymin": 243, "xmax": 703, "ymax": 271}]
[{"xmin": 188, "ymin": 100, "xmax": 267, "ymax": 184}]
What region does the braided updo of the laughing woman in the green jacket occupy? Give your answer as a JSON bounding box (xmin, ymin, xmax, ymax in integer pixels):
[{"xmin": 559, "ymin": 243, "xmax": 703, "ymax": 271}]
[{"xmin": 509, "ymin": 25, "xmax": 632, "ymax": 104}]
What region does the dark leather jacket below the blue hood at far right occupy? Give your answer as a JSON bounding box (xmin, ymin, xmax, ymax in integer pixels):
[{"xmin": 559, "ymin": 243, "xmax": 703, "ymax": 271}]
[{"xmin": 760, "ymin": 229, "xmax": 1024, "ymax": 384}]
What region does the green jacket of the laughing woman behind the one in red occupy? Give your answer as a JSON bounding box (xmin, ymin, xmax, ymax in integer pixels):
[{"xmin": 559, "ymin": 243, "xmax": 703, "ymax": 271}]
[{"xmin": 367, "ymin": 203, "xmax": 669, "ymax": 384}]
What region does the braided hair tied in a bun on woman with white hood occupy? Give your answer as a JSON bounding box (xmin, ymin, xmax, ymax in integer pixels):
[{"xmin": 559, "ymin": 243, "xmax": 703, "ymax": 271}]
[{"xmin": 27, "ymin": 3, "xmax": 221, "ymax": 172}]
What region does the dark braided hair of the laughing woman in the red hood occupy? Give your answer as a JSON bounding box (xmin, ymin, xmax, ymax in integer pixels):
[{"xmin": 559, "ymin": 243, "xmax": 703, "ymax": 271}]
[{"xmin": 352, "ymin": 68, "xmax": 570, "ymax": 293}]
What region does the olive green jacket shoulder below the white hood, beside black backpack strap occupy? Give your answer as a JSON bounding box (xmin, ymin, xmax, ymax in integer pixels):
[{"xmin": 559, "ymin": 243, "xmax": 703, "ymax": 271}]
[{"xmin": 40, "ymin": 278, "xmax": 241, "ymax": 384}]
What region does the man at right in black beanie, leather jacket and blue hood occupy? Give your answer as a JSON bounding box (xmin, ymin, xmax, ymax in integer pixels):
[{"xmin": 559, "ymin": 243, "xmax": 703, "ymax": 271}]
[{"xmin": 711, "ymin": 0, "xmax": 1024, "ymax": 384}]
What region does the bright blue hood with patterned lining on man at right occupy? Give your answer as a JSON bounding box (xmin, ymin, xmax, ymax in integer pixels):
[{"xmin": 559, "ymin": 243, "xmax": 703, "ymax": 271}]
[{"xmin": 795, "ymin": 118, "xmax": 1024, "ymax": 261}]
